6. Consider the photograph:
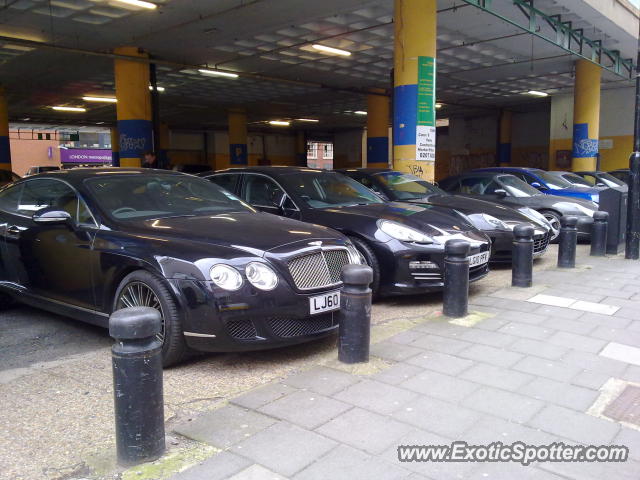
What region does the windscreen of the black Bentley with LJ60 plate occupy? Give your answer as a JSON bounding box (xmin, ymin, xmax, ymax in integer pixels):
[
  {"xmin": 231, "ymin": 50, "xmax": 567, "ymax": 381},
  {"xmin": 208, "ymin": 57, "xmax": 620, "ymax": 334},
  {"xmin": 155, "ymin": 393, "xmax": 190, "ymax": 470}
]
[{"xmin": 85, "ymin": 173, "xmax": 255, "ymax": 220}]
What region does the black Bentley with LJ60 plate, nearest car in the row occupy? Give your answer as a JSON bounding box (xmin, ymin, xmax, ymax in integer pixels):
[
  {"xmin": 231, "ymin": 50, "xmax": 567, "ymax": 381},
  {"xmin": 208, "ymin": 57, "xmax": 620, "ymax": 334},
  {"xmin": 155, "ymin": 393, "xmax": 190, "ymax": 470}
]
[{"xmin": 0, "ymin": 168, "xmax": 361, "ymax": 365}]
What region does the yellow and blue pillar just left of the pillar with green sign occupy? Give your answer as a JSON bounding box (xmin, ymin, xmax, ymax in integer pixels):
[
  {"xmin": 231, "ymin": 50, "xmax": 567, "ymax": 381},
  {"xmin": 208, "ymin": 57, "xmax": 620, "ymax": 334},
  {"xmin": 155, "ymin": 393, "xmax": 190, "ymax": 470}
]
[{"xmin": 367, "ymin": 90, "xmax": 389, "ymax": 168}]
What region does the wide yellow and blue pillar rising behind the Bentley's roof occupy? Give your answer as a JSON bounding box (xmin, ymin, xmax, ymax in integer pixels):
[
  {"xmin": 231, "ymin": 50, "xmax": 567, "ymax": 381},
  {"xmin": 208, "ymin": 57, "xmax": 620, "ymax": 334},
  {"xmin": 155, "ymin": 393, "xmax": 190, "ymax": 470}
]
[{"xmin": 114, "ymin": 47, "xmax": 153, "ymax": 167}]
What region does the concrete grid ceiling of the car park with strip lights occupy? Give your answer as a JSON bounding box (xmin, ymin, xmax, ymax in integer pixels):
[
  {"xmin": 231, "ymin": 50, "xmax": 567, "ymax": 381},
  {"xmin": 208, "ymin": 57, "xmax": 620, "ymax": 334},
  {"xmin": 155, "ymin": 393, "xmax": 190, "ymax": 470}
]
[{"xmin": 0, "ymin": 0, "xmax": 637, "ymax": 130}]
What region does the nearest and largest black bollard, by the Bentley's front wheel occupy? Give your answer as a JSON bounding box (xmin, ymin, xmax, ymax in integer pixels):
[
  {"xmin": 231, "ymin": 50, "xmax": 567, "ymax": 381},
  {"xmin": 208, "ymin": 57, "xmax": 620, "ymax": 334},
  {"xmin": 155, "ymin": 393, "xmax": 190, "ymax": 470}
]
[{"xmin": 109, "ymin": 307, "xmax": 165, "ymax": 466}]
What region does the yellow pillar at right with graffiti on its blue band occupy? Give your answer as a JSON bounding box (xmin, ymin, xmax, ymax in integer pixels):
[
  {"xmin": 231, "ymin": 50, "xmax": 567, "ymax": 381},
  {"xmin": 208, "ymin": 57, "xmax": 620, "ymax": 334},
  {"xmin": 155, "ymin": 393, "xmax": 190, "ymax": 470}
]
[{"xmin": 571, "ymin": 59, "xmax": 602, "ymax": 172}]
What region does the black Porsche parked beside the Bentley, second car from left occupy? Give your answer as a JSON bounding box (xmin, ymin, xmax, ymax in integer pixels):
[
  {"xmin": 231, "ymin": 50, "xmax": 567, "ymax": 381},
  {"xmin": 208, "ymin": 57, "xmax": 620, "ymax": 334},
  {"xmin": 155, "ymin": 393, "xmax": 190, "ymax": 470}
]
[{"xmin": 201, "ymin": 167, "xmax": 491, "ymax": 295}]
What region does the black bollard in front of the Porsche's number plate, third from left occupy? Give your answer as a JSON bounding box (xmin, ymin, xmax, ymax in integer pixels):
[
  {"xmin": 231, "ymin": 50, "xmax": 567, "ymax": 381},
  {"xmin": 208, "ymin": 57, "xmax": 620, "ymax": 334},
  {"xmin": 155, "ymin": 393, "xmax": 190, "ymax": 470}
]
[{"xmin": 442, "ymin": 239, "xmax": 471, "ymax": 318}]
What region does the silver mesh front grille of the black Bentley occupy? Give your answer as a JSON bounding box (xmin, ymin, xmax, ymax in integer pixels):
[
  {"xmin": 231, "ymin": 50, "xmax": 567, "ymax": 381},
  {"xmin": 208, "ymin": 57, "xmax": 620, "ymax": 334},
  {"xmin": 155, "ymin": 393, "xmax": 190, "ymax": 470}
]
[{"xmin": 289, "ymin": 249, "xmax": 349, "ymax": 290}]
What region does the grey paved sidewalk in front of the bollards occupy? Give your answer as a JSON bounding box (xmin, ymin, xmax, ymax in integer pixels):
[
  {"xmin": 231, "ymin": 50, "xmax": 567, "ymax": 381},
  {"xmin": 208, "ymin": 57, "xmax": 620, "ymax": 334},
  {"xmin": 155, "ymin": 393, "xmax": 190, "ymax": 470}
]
[{"xmin": 171, "ymin": 256, "xmax": 640, "ymax": 480}]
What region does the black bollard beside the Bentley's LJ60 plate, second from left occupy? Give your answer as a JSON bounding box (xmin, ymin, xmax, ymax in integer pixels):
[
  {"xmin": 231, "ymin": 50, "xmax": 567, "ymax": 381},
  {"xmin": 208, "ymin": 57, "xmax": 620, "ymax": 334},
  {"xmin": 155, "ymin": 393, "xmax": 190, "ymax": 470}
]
[{"xmin": 338, "ymin": 265, "xmax": 373, "ymax": 363}]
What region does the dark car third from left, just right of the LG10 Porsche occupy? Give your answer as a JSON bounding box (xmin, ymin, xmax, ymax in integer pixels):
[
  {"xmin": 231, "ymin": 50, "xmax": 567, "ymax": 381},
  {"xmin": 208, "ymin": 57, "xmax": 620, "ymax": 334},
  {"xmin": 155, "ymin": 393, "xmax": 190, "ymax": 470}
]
[{"xmin": 338, "ymin": 168, "xmax": 551, "ymax": 262}]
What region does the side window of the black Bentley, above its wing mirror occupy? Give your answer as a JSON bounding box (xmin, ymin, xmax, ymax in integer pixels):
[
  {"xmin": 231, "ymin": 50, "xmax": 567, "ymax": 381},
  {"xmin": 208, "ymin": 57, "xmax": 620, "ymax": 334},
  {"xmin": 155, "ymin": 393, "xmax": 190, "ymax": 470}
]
[{"xmin": 18, "ymin": 178, "xmax": 94, "ymax": 224}]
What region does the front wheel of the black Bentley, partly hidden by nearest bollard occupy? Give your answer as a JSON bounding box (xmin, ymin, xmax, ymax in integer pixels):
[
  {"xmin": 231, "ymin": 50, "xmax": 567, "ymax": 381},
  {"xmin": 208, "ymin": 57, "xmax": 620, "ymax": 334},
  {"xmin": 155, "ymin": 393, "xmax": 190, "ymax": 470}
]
[{"xmin": 113, "ymin": 270, "xmax": 188, "ymax": 367}]
